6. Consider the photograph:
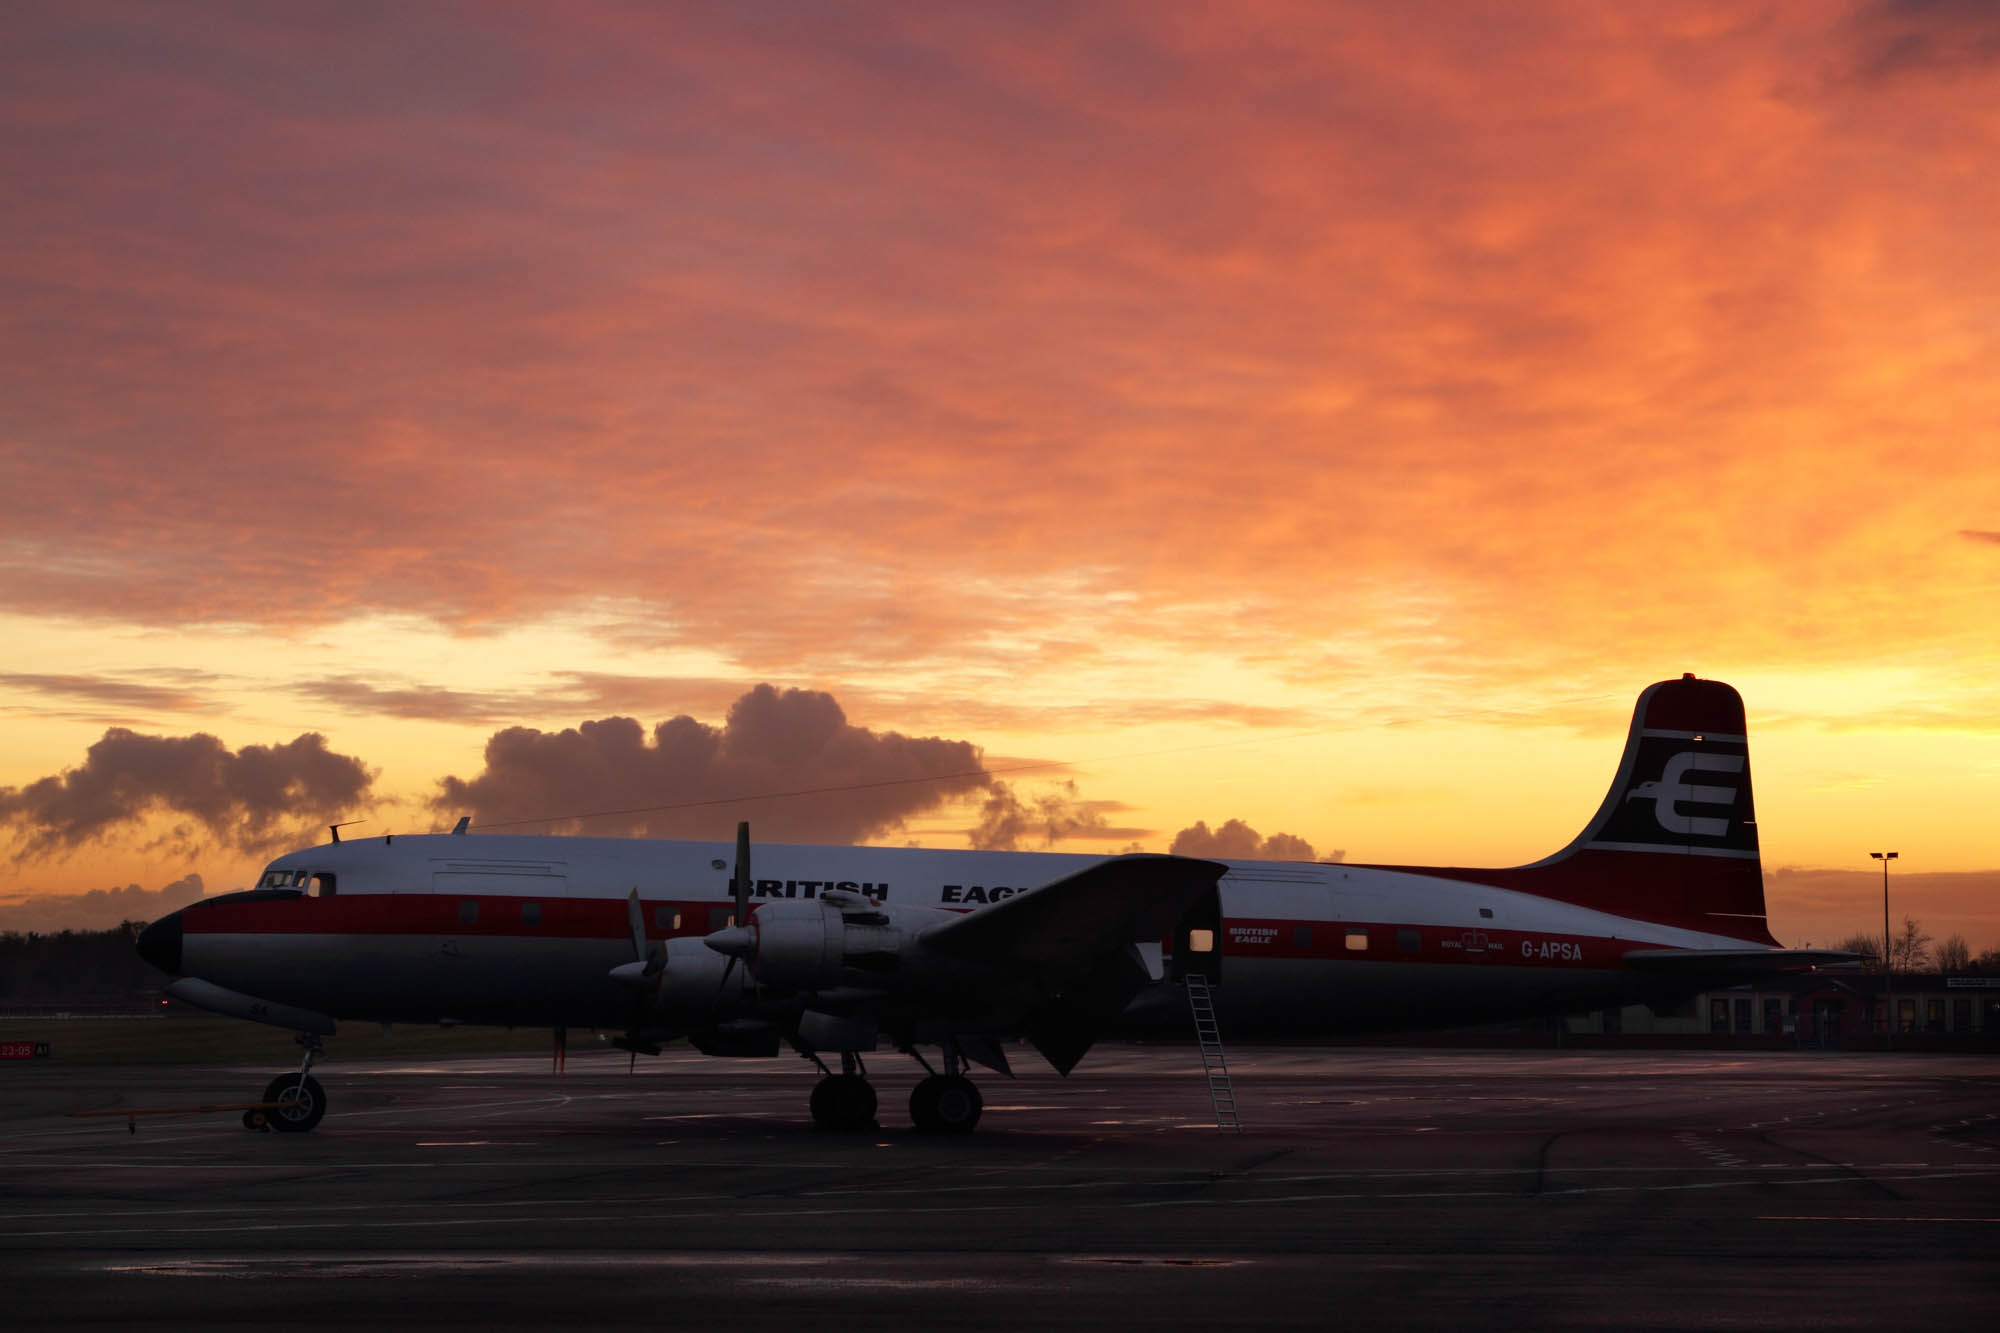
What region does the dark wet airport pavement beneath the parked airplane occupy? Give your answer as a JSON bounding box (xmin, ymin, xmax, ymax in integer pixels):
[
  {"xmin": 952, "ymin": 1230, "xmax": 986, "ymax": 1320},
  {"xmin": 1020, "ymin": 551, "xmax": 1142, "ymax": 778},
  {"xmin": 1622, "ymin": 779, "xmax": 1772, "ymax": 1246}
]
[{"xmin": 0, "ymin": 1045, "xmax": 2000, "ymax": 1331}]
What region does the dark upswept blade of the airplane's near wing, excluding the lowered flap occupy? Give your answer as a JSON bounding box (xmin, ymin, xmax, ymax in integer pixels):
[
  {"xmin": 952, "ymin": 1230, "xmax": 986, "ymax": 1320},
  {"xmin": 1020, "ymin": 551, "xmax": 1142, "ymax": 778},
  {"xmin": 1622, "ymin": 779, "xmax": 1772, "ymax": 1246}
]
[{"xmin": 922, "ymin": 853, "xmax": 1228, "ymax": 971}]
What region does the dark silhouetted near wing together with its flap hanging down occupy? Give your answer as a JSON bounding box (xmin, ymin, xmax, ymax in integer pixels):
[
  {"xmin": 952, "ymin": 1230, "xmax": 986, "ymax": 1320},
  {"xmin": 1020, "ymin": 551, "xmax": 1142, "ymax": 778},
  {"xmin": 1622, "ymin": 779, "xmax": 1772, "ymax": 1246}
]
[{"xmin": 920, "ymin": 855, "xmax": 1228, "ymax": 1075}]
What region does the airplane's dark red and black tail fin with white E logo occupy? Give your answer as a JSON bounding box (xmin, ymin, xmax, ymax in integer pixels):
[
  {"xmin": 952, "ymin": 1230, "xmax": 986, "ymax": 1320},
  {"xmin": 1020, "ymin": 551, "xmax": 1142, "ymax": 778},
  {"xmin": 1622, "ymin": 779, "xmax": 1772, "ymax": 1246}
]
[{"xmin": 1384, "ymin": 675, "xmax": 1778, "ymax": 945}]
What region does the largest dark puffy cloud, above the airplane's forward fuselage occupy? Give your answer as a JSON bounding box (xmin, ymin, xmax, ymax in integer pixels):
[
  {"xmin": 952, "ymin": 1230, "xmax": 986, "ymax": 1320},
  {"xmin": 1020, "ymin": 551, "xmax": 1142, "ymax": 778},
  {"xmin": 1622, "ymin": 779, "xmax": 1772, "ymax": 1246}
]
[{"xmin": 432, "ymin": 685, "xmax": 988, "ymax": 843}]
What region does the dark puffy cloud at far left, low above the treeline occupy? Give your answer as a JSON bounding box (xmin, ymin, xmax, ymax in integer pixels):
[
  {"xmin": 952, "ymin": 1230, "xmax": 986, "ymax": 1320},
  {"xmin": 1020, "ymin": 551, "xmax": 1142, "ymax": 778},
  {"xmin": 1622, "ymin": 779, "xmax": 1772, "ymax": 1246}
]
[{"xmin": 0, "ymin": 727, "xmax": 374, "ymax": 859}]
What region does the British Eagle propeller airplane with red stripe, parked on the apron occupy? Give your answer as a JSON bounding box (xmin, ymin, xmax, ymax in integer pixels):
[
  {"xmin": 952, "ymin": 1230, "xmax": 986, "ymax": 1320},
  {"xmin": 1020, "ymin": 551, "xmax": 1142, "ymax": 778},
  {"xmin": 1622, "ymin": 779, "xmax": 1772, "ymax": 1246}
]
[{"xmin": 138, "ymin": 675, "xmax": 1856, "ymax": 1133}]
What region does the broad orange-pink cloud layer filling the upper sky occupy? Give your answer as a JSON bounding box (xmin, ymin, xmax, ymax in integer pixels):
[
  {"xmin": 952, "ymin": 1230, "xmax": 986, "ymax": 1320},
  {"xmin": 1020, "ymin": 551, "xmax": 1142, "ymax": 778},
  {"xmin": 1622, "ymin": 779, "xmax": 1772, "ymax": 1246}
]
[{"xmin": 0, "ymin": 4, "xmax": 2000, "ymax": 704}]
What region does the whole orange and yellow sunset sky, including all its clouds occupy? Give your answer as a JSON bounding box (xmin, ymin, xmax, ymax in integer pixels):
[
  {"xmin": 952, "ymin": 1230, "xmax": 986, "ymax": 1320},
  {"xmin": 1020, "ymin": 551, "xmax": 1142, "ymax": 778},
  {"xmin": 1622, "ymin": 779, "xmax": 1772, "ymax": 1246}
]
[{"xmin": 0, "ymin": 0, "xmax": 2000, "ymax": 953}]
